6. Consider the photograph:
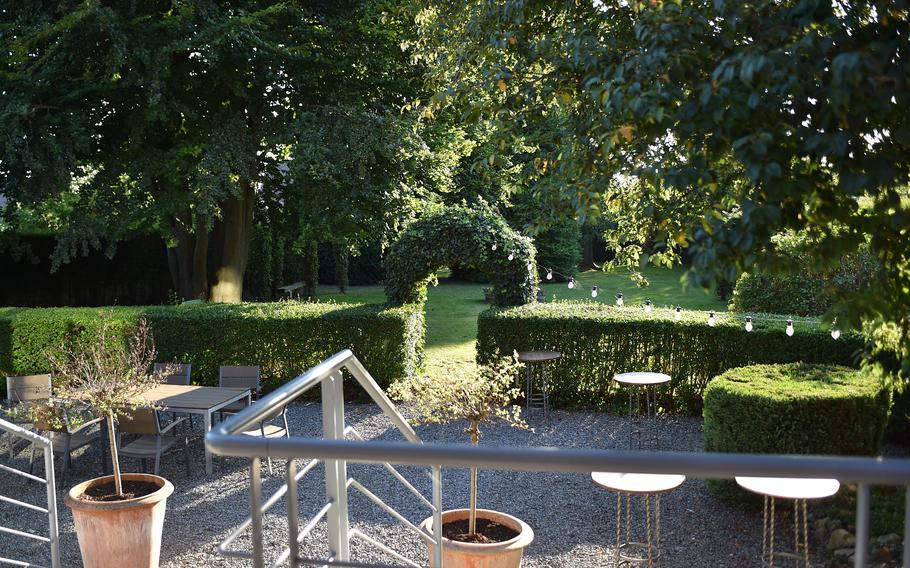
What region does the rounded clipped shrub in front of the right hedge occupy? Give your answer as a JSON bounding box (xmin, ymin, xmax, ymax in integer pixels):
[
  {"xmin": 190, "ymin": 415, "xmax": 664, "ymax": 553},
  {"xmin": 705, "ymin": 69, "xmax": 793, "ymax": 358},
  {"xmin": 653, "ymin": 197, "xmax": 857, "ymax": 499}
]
[{"xmin": 704, "ymin": 363, "xmax": 891, "ymax": 503}]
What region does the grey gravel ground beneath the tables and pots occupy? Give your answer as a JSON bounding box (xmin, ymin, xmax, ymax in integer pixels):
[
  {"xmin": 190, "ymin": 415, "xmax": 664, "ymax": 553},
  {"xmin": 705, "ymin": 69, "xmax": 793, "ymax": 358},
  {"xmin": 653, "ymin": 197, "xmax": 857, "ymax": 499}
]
[{"xmin": 0, "ymin": 404, "xmax": 820, "ymax": 568}]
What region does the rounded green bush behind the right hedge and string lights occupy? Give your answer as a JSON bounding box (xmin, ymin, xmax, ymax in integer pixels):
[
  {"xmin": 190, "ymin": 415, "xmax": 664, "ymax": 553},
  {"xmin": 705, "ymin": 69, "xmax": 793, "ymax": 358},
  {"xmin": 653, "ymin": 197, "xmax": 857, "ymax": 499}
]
[{"xmin": 730, "ymin": 234, "xmax": 879, "ymax": 316}]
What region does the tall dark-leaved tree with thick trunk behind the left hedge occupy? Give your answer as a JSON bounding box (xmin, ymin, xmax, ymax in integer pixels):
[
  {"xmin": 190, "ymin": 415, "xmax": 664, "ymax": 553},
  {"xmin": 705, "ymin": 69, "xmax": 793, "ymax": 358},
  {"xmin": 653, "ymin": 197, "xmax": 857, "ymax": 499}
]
[{"xmin": 0, "ymin": 0, "xmax": 418, "ymax": 301}]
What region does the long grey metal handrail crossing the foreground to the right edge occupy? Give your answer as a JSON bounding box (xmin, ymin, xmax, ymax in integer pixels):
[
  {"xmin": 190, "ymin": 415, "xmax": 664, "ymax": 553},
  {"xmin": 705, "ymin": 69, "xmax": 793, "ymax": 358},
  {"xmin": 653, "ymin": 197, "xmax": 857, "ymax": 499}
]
[{"xmin": 206, "ymin": 350, "xmax": 910, "ymax": 568}]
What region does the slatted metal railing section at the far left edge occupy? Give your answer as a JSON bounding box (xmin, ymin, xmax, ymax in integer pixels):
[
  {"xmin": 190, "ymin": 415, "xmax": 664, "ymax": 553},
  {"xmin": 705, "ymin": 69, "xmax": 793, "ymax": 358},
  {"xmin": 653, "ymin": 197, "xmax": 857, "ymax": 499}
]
[{"xmin": 0, "ymin": 419, "xmax": 60, "ymax": 568}]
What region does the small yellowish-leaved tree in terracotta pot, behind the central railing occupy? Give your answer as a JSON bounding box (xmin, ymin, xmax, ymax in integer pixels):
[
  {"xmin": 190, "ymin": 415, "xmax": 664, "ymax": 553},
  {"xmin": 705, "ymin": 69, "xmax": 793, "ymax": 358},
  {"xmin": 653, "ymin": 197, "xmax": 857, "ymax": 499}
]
[{"xmin": 390, "ymin": 356, "xmax": 534, "ymax": 568}]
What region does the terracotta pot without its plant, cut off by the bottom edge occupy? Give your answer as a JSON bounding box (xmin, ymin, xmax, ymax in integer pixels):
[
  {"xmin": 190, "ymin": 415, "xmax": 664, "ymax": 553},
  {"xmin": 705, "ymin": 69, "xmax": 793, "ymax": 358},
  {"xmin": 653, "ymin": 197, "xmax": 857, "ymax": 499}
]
[{"xmin": 420, "ymin": 509, "xmax": 534, "ymax": 568}]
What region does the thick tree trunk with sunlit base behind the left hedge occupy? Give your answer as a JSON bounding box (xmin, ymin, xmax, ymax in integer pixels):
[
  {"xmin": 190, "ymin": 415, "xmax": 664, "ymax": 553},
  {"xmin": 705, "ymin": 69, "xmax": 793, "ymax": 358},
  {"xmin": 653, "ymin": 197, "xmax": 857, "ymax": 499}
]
[{"xmin": 209, "ymin": 181, "xmax": 256, "ymax": 303}]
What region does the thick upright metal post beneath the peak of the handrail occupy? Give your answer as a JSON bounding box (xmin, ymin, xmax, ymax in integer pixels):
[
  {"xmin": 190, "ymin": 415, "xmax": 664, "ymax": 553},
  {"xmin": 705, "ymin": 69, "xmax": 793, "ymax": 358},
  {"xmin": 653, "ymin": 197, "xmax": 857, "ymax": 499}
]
[{"xmin": 322, "ymin": 371, "xmax": 350, "ymax": 562}]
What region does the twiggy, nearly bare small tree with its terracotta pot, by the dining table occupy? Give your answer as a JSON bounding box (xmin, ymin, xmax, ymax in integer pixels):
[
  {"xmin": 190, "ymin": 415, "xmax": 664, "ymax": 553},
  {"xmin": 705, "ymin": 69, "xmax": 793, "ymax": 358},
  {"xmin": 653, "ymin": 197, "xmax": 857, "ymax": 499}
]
[{"xmin": 47, "ymin": 312, "xmax": 174, "ymax": 568}]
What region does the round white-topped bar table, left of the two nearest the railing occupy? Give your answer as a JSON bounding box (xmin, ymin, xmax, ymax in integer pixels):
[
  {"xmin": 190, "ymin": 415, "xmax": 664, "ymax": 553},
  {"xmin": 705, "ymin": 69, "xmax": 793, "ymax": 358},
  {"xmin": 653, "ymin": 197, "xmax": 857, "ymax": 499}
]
[{"xmin": 591, "ymin": 471, "xmax": 686, "ymax": 568}]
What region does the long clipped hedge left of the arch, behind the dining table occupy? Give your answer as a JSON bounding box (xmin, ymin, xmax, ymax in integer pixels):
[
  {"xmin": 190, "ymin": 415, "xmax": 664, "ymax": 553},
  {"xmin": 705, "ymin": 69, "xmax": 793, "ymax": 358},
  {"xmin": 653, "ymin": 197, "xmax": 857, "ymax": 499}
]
[{"xmin": 0, "ymin": 302, "xmax": 425, "ymax": 389}]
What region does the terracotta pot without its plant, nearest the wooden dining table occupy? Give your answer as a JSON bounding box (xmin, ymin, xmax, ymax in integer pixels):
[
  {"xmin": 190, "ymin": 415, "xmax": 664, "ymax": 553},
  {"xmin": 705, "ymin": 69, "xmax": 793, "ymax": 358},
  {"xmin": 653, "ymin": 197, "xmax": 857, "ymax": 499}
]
[{"xmin": 64, "ymin": 473, "xmax": 174, "ymax": 568}]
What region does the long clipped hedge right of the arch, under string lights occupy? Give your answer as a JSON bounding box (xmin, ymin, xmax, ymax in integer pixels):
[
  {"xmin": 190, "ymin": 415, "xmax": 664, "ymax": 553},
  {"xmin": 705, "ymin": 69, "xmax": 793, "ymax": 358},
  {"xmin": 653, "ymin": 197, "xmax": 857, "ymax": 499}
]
[{"xmin": 477, "ymin": 302, "xmax": 863, "ymax": 414}]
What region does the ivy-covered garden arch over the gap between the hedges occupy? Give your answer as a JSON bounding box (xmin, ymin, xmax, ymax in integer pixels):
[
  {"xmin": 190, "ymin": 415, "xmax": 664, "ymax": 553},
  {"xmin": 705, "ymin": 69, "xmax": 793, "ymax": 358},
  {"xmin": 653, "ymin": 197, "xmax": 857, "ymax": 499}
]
[{"xmin": 385, "ymin": 205, "xmax": 537, "ymax": 306}]
